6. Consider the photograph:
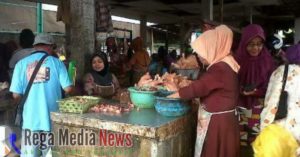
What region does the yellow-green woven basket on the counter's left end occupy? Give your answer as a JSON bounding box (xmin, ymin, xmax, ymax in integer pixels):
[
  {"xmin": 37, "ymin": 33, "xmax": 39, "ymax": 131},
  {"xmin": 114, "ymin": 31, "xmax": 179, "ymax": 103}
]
[{"xmin": 57, "ymin": 96, "xmax": 100, "ymax": 114}]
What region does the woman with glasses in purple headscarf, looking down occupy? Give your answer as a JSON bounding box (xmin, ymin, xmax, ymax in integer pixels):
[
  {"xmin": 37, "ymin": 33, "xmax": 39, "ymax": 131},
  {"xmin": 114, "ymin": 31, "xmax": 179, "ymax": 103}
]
[{"xmin": 236, "ymin": 24, "xmax": 275, "ymax": 143}]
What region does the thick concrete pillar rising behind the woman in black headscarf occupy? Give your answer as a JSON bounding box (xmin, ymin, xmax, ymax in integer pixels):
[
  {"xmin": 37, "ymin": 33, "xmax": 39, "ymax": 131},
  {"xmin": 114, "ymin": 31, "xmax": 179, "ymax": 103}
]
[{"xmin": 66, "ymin": 0, "xmax": 95, "ymax": 79}]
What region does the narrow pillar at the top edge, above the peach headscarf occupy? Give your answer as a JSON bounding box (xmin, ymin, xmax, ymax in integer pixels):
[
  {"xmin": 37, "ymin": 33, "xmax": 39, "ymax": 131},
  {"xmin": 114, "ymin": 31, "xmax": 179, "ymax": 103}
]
[{"xmin": 201, "ymin": 0, "xmax": 214, "ymax": 21}]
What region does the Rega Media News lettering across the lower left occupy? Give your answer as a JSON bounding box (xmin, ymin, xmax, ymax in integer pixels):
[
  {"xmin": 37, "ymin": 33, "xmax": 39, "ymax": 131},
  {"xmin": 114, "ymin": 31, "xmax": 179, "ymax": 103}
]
[{"xmin": 23, "ymin": 129, "xmax": 133, "ymax": 150}]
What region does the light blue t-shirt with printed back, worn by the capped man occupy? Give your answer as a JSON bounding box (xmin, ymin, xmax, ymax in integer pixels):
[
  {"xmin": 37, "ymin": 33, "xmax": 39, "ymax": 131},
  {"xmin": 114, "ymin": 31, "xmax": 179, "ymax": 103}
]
[{"xmin": 9, "ymin": 52, "xmax": 72, "ymax": 131}]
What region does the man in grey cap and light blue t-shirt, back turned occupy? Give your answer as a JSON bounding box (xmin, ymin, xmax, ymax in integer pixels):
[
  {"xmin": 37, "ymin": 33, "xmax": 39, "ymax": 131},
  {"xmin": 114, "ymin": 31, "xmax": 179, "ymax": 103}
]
[{"xmin": 10, "ymin": 34, "xmax": 72, "ymax": 157}]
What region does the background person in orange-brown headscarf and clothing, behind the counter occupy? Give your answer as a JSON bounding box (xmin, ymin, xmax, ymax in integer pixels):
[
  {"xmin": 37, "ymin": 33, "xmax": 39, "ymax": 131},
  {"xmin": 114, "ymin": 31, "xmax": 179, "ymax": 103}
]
[{"xmin": 128, "ymin": 37, "xmax": 150, "ymax": 83}]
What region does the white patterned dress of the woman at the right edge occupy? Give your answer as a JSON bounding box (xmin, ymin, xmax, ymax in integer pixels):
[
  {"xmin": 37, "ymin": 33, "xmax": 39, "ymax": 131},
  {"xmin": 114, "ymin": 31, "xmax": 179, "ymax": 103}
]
[{"xmin": 261, "ymin": 65, "xmax": 300, "ymax": 143}]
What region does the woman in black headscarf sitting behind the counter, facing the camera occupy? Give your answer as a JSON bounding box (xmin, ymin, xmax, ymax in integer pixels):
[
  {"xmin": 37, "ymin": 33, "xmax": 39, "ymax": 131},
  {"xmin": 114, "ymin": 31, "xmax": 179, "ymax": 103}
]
[{"xmin": 83, "ymin": 52, "xmax": 120, "ymax": 97}]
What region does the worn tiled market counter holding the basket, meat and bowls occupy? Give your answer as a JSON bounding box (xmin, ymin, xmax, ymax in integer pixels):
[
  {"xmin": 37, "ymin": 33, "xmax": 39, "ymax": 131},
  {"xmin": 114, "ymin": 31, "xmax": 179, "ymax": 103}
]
[{"xmin": 51, "ymin": 108, "xmax": 196, "ymax": 157}]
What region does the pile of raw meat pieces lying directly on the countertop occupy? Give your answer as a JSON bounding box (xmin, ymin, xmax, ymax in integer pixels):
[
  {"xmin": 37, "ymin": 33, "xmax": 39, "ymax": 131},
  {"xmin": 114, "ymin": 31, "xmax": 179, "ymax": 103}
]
[{"xmin": 90, "ymin": 103, "xmax": 134, "ymax": 114}]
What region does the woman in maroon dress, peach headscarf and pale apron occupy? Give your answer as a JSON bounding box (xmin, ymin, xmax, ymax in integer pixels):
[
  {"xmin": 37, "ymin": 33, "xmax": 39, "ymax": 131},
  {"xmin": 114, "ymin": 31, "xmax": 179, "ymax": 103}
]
[{"xmin": 166, "ymin": 25, "xmax": 239, "ymax": 157}]
